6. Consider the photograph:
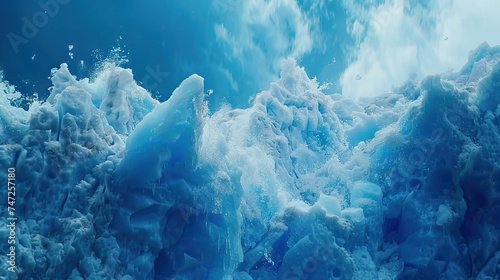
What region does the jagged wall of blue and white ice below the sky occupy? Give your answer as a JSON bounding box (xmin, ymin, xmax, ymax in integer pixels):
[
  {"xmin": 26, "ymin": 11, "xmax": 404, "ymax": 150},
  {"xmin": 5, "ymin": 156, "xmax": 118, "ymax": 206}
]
[{"xmin": 0, "ymin": 44, "xmax": 500, "ymax": 280}]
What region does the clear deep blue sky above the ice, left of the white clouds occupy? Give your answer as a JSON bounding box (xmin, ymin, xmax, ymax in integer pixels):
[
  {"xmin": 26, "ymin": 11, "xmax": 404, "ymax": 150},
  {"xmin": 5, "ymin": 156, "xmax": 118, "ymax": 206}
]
[{"xmin": 0, "ymin": 0, "xmax": 351, "ymax": 106}]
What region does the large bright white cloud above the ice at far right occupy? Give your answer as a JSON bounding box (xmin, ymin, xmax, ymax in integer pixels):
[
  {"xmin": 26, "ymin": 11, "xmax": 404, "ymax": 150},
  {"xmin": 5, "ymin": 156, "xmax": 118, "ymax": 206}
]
[{"xmin": 341, "ymin": 0, "xmax": 500, "ymax": 98}]
